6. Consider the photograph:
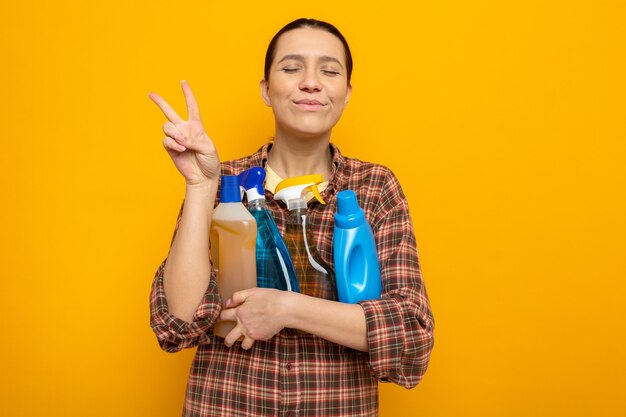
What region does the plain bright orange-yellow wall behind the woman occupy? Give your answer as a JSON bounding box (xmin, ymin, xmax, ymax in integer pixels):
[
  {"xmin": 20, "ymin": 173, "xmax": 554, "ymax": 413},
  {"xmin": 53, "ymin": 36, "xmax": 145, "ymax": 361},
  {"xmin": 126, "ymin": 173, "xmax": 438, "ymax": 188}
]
[{"xmin": 0, "ymin": 0, "xmax": 626, "ymax": 417}]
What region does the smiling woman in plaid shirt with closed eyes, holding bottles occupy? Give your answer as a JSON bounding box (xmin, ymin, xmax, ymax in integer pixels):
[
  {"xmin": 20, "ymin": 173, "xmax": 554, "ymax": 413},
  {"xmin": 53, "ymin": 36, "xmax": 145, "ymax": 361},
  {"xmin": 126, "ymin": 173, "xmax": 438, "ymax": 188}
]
[{"xmin": 150, "ymin": 19, "xmax": 433, "ymax": 416}]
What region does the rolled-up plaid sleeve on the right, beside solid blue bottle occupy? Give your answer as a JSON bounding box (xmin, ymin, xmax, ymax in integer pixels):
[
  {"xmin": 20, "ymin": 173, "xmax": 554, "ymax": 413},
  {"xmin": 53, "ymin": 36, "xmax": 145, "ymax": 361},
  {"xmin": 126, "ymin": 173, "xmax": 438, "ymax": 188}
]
[{"xmin": 360, "ymin": 171, "xmax": 434, "ymax": 388}]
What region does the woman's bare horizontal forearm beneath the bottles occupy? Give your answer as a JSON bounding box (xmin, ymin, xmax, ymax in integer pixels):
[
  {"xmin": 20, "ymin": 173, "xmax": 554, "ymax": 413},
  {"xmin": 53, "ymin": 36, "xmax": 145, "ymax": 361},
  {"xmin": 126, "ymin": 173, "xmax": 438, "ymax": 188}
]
[{"xmin": 286, "ymin": 293, "xmax": 368, "ymax": 352}]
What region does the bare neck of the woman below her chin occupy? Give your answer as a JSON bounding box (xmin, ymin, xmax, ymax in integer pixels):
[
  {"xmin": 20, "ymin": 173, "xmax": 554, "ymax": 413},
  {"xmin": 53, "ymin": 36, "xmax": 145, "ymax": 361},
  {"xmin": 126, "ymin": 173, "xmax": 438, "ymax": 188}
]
[{"xmin": 268, "ymin": 135, "xmax": 332, "ymax": 180}]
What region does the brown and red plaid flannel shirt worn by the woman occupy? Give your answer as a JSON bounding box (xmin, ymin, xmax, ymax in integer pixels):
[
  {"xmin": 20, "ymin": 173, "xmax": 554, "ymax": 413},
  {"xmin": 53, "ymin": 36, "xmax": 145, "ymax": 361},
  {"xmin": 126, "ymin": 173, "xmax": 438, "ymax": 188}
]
[{"xmin": 150, "ymin": 144, "xmax": 434, "ymax": 417}]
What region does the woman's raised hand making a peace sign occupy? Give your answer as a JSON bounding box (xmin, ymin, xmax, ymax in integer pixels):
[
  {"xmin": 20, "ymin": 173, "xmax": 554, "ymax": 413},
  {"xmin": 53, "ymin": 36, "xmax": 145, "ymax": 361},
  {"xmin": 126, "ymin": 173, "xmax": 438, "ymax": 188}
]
[{"xmin": 148, "ymin": 81, "xmax": 220, "ymax": 186}]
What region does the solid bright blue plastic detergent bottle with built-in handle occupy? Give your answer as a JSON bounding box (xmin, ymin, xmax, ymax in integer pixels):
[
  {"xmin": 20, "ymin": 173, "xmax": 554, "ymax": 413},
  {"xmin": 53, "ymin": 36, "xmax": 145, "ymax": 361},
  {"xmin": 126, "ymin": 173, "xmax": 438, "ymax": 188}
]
[{"xmin": 333, "ymin": 190, "xmax": 382, "ymax": 303}]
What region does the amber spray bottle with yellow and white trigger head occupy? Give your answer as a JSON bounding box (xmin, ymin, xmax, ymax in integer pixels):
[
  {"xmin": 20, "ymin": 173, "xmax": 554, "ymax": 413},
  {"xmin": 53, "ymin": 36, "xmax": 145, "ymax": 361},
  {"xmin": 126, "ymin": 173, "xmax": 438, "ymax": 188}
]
[{"xmin": 274, "ymin": 175, "xmax": 337, "ymax": 300}]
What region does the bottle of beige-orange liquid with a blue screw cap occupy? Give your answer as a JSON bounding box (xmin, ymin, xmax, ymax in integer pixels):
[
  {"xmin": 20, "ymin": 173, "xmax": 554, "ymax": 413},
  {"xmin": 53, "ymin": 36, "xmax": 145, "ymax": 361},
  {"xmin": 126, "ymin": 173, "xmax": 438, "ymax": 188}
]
[{"xmin": 210, "ymin": 175, "xmax": 256, "ymax": 337}]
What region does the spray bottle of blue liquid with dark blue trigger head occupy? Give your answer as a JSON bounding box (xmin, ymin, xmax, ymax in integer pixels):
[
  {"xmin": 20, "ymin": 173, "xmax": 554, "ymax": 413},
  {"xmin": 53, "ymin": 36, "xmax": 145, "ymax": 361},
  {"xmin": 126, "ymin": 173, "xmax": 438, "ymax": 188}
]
[{"xmin": 240, "ymin": 167, "xmax": 300, "ymax": 292}]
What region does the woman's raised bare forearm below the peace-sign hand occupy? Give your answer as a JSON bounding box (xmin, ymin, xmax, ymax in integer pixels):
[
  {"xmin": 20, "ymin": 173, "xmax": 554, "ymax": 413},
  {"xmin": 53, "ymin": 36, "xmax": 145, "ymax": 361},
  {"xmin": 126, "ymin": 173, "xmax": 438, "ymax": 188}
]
[{"xmin": 163, "ymin": 182, "xmax": 217, "ymax": 322}]
